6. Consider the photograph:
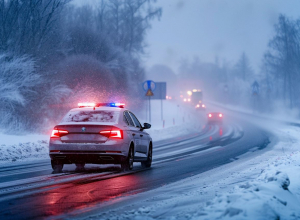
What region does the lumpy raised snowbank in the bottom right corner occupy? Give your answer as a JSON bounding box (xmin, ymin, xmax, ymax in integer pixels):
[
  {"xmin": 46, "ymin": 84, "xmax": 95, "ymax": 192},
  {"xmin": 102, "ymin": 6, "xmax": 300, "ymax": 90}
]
[{"xmin": 197, "ymin": 151, "xmax": 300, "ymax": 220}]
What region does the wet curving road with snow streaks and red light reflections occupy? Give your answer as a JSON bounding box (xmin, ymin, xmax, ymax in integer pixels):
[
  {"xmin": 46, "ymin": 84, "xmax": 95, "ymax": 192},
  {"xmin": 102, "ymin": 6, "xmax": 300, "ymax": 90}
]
[{"xmin": 0, "ymin": 112, "xmax": 269, "ymax": 219}]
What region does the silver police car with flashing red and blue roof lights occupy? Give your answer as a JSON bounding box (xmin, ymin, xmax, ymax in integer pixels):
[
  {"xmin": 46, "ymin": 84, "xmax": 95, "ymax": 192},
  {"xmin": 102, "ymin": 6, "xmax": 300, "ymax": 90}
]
[{"xmin": 49, "ymin": 103, "xmax": 153, "ymax": 172}]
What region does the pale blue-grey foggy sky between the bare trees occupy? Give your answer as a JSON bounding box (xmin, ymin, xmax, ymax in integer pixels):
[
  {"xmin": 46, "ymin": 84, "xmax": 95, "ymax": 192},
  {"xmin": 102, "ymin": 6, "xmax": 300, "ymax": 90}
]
[{"xmin": 144, "ymin": 0, "xmax": 300, "ymax": 72}]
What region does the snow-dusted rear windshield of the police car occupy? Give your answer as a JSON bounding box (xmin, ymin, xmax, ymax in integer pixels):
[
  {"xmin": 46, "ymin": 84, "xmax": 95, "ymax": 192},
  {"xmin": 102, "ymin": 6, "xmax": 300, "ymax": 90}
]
[{"xmin": 61, "ymin": 110, "xmax": 119, "ymax": 122}]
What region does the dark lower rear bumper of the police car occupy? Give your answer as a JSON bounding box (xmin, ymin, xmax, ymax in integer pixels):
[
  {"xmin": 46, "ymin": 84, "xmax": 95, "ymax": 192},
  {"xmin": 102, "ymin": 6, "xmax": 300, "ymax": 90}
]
[{"xmin": 49, "ymin": 151, "xmax": 127, "ymax": 164}]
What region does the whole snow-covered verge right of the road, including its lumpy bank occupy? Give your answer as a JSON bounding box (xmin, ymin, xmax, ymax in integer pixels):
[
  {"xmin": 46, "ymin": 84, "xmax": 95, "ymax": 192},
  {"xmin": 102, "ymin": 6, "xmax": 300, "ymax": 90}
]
[{"xmin": 89, "ymin": 126, "xmax": 300, "ymax": 219}]
